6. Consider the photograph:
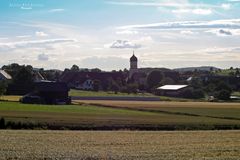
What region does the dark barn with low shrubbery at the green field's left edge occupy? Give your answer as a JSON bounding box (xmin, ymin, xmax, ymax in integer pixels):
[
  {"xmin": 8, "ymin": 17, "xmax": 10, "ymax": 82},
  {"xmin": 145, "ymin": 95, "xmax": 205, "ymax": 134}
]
[{"xmin": 21, "ymin": 82, "xmax": 71, "ymax": 104}]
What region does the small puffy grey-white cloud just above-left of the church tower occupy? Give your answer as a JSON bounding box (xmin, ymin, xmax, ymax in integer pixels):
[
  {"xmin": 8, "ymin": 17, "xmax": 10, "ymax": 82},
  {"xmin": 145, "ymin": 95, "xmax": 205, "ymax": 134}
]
[{"xmin": 105, "ymin": 40, "xmax": 141, "ymax": 49}]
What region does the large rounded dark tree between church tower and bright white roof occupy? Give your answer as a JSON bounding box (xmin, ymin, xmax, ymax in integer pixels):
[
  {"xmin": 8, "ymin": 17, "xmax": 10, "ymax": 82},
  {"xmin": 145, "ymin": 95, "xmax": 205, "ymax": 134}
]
[{"xmin": 147, "ymin": 71, "xmax": 164, "ymax": 89}]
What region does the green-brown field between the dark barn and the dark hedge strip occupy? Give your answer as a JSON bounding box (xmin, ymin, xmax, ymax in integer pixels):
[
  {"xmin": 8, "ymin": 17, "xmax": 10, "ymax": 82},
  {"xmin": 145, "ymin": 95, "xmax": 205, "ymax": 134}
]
[{"xmin": 0, "ymin": 102, "xmax": 240, "ymax": 130}]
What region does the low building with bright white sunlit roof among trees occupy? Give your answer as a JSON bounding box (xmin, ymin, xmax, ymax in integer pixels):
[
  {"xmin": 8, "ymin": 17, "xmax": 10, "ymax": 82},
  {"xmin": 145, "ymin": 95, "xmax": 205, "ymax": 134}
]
[{"xmin": 156, "ymin": 85, "xmax": 188, "ymax": 97}]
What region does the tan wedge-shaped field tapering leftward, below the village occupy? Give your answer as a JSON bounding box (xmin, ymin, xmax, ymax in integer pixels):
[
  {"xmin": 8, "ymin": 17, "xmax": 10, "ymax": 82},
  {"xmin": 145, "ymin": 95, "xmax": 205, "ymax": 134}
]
[{"xmin": 79, "ymin": 101, "xmax": 240, "ymax": 120}]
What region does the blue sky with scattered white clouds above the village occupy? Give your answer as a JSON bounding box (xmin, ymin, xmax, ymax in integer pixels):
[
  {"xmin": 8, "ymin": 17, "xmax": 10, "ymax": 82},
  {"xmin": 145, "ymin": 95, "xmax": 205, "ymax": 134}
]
[{"xmin": 0, "ymin": 0, "xmax": 240, "ymax": 71}]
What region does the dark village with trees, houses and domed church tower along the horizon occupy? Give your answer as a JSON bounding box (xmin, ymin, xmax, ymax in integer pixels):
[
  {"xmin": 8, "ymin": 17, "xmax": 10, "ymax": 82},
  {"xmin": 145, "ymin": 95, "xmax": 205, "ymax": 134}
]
[{"xmin": 0, "ymin": 53, "xmax": 240, "ymax": 104}]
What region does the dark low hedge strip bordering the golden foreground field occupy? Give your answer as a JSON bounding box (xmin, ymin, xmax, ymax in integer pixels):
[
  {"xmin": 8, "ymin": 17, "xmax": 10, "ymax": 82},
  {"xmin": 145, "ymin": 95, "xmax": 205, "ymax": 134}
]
[{"xmin": 0, "ymin": 118, "xmax": 240, "ymax": 131}]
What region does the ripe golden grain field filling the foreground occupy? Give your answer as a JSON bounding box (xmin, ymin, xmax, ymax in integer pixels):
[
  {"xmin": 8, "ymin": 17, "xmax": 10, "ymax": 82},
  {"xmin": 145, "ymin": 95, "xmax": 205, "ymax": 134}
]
[{"xmin": 0, "ymin": 130, "xmax": 240, "ymax": 160}]
